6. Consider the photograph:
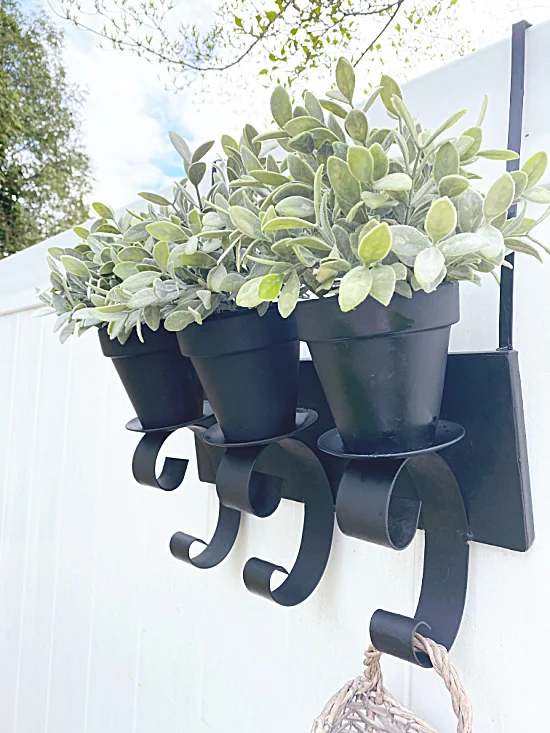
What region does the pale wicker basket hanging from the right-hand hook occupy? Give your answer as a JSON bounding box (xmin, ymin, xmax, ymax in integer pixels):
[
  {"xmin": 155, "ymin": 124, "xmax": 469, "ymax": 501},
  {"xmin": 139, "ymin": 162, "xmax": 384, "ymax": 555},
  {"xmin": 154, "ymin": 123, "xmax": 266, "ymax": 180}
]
[{"xmin": 311, "ymin": 635, "xmax": 472, "ymax": 733}]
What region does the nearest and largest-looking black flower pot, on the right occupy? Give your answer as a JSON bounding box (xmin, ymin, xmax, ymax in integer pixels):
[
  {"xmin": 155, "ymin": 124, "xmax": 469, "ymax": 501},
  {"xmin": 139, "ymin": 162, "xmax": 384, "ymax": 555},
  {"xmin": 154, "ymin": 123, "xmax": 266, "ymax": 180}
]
[{"xmin": 296, "ymin": 283, "xmax": 460, "ymax": 454}]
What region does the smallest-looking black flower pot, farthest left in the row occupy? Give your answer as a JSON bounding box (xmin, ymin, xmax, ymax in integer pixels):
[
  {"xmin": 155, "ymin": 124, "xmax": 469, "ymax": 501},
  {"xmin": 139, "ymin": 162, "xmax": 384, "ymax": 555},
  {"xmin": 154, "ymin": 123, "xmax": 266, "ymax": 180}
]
[{"xmin": 99, "ymin": 324, "xmax": 203, "ymax": 430}]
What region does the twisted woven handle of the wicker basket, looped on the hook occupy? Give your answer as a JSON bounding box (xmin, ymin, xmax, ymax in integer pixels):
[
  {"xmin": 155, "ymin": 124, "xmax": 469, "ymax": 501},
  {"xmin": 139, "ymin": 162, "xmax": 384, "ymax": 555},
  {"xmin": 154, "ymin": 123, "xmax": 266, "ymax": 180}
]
[{"xmin": 364, "ymin": 634, "xmax": 473, "ymax": 733}]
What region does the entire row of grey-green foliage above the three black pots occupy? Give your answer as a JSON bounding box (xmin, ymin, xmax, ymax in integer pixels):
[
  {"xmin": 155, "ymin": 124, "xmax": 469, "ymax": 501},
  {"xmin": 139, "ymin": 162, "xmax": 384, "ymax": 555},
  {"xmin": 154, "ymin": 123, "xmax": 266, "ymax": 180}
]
[{"xmin": 41, "ymin": 58, "xmax": 550, "ymax": 340}]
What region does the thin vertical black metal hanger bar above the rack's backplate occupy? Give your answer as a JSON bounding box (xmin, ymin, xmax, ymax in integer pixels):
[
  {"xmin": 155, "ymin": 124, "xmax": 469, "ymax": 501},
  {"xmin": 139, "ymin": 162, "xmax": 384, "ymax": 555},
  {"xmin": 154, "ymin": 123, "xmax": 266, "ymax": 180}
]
[{"xmin": 498, "ymin": 20, "xmax": 531, "ymax": 350}]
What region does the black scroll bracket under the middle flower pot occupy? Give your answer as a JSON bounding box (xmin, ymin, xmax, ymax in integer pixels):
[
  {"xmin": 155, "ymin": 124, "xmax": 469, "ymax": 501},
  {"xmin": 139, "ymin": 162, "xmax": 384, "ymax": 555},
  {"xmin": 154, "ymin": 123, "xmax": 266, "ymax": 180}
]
[{"xmin": 217, "ymin": 438, "xmax": 334, "ymax": 606}]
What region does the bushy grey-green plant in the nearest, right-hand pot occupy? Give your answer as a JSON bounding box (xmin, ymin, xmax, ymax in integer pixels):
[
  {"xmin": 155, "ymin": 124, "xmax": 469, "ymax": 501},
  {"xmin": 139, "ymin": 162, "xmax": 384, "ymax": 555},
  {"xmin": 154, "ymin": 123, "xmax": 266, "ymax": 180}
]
[{"xmin": 221, "ymin": 58, "xmax": 550, "ymax": 316}]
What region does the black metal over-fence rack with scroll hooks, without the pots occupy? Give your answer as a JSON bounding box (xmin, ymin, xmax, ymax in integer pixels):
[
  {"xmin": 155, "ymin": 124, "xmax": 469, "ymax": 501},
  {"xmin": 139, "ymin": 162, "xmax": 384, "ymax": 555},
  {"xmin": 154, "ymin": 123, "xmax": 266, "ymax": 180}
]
[{"xmin": 127, "ymin": 22, "xmax": 534, "ymax": 667}]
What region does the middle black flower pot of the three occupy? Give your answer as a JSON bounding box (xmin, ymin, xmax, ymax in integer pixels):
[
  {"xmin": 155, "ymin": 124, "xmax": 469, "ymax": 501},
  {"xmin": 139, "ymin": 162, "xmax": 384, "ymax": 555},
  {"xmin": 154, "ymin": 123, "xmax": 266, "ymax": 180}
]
[{"xmin": 178, "ymin": 308, "xmax": 300, "ymax": 442}]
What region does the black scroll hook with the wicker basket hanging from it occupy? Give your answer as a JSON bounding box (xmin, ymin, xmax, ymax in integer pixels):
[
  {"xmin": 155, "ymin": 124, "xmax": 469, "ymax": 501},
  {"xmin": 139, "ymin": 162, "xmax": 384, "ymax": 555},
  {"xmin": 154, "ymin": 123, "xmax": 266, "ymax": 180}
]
[{"xmin": 336, "ymin": 453, "xmax": 470, "ymax": 667}]
